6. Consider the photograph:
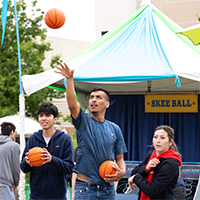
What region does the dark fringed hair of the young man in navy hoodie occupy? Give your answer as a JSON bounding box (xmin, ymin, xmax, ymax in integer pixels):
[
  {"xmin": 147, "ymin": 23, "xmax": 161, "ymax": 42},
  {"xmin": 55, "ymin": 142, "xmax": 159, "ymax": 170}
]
[{"xmin": 38, "ymin": 103, "xmax": 58, "ymax": 118}]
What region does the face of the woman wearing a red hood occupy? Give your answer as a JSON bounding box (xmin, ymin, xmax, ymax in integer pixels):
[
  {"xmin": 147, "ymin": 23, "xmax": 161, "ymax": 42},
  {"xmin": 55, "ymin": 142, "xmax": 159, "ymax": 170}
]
[{"xmin": 153, "ymin": 130, "xmax": 173, "ymax": 156}]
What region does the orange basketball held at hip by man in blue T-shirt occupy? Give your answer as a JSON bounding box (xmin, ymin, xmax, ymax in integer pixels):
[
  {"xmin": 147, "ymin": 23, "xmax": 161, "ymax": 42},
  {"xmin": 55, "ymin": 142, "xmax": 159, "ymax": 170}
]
[{"xmin": 99, "ymin": 160, "xmax": 117, "ymax": 179}]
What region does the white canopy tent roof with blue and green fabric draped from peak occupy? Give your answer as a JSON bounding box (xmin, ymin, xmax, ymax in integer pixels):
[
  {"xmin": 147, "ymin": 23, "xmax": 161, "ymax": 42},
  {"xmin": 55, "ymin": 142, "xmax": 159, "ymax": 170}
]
[{"xmin": 22, "ymin": 4, "xmax": 200, "ymax": 101}]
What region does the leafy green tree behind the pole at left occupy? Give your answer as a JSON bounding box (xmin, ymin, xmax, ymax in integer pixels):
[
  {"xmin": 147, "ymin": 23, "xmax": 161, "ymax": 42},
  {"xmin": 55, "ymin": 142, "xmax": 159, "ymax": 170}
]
[{"xmin": 0, "ymin": 0, "xmax": 64, "ymax": 119}]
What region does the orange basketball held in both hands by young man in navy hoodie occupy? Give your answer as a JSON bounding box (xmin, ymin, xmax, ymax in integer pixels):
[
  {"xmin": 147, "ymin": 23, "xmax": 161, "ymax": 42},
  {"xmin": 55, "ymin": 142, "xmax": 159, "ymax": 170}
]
[{"xmin": 28, "ymin": 147, "xmax": 44, "ymax": 167}]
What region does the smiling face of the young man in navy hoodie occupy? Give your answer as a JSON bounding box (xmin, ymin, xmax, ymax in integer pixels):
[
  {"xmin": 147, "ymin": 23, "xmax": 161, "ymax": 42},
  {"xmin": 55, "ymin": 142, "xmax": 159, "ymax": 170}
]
[{"xmin": 38, "ymin": 113, "xmax": 57, "ymax": 129}]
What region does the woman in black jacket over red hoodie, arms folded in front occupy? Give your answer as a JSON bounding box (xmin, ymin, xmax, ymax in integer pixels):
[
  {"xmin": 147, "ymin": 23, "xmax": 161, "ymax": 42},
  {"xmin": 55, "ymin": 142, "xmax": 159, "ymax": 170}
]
[{"xmin": 128, "ymin": 125, "xmax": 182, "ymax": 200}]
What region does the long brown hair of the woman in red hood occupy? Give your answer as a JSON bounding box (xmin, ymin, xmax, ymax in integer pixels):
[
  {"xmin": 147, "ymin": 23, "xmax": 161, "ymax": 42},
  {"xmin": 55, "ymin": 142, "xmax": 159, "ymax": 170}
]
[{"xmin": 154, "ymin": 125, "xmax": 181, "ymax": 156}]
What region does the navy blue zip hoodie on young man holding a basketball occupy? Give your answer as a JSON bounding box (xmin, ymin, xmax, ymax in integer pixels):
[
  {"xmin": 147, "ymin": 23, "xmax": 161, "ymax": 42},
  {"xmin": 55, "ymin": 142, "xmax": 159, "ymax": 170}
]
[{"xmin": 20, "ymin": 130, "xmax": 74, "ymax": 200}]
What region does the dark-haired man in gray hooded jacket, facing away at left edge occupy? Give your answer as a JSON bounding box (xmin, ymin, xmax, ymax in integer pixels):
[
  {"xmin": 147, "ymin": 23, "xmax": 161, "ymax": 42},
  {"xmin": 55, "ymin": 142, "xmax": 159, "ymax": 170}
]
[{"xmin": 0, "ymin": 122, "xmax": 20, "ymax": 200}]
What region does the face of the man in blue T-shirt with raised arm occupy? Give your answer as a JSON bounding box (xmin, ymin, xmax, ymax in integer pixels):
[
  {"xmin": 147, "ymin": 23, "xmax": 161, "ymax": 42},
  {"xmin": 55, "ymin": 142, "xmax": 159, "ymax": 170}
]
[{"xmin": 89, "ymin": 91, "xmax": 109, "ymax": 113}]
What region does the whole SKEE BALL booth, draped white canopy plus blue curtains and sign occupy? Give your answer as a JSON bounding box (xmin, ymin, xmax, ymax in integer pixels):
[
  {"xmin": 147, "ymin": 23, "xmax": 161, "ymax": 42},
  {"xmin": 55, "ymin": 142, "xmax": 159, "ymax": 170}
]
[{"xmin": 22, "ymin": 4, "xmax": 200, "ymax": 199}]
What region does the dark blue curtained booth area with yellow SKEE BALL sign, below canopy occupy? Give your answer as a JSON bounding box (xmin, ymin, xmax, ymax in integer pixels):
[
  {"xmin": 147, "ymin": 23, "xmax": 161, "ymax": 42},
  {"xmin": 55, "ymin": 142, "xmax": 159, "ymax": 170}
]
[{"xmin": 106, "ymin": 94, "xmax": 200, "ymax": 199}]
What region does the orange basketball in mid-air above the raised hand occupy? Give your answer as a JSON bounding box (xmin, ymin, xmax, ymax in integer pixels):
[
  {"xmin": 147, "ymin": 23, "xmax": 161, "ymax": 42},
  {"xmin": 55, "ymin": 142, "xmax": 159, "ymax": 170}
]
[{"xmin": 44, "ymin": 8, "xmax": 65, "ymax": 29}]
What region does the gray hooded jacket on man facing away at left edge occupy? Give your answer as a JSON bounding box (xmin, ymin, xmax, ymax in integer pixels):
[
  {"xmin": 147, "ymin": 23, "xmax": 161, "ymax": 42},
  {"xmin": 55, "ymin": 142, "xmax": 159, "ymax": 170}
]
[{"xmin": 0, "ymin": 135, "xmax": 20, "ymax": 187}]
